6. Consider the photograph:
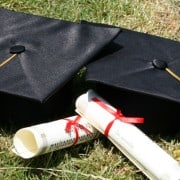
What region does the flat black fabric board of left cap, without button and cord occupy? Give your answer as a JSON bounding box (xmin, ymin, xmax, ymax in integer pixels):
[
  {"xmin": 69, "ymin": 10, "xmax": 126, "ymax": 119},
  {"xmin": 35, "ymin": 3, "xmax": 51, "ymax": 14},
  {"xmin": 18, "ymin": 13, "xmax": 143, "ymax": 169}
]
[{"xmin": 0, "ymin": 9, "xmax": 119, "ymax": 102}]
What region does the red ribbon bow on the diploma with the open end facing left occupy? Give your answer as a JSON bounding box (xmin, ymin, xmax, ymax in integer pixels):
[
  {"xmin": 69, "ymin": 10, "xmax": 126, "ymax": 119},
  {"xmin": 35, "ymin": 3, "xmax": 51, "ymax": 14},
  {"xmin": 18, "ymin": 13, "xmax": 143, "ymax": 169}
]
[{"xmin": 65, "ymin": 116, "xmax": 92, "ymax": 145}]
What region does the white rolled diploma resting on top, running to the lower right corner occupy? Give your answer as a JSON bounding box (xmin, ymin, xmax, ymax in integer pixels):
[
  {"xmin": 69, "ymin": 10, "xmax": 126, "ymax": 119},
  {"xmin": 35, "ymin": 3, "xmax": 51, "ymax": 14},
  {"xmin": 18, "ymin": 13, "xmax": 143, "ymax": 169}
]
[{"xmin": 76, "ymin": 90, "xmax": 180, "ymax": 180}]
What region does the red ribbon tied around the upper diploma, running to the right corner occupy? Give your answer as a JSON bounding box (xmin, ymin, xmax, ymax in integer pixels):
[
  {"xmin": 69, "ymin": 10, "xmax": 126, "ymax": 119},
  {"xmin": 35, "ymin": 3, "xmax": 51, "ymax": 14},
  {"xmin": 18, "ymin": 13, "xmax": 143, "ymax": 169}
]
[{"xmin": 92, "ymin": 98, "xmax": 144, "ymax": 137}]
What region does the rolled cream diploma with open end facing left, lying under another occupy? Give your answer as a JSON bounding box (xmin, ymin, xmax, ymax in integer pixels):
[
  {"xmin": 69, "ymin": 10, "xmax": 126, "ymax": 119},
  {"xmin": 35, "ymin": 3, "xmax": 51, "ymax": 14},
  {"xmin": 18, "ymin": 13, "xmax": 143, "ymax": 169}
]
[{"xmin": 12, "ymin": 116, "xmax": 98, "ymax": 159}]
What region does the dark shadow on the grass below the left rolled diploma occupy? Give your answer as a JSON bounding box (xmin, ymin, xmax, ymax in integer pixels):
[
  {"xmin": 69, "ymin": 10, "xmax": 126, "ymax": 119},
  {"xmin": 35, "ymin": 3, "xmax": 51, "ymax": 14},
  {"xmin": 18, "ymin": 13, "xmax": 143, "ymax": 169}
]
[{"xmin": 13, "ymin": 141, "xmax": 97, "ymax": 179}]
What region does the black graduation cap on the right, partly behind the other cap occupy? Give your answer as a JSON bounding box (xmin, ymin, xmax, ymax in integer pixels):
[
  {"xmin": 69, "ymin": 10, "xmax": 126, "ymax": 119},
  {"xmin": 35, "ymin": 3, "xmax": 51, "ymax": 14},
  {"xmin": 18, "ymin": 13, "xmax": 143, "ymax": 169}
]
[{"xmin": 86, "ymin": 21, "xmax": 180, "ymax": 133}]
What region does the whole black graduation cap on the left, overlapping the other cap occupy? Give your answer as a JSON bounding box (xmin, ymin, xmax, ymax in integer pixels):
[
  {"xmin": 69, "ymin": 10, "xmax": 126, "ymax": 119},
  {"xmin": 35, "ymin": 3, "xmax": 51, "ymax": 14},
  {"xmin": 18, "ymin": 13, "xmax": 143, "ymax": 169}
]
[{"xmin": 0, "ymin": 9, "xmax": 119, "ymax": 126}]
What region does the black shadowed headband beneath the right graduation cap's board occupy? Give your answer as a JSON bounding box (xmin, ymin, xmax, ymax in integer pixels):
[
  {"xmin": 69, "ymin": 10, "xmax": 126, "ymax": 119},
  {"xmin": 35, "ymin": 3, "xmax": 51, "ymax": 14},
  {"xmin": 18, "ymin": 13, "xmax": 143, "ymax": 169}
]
[{"xmin": 92, "ymin": 83, "xmax": 180, "ymax": 135}]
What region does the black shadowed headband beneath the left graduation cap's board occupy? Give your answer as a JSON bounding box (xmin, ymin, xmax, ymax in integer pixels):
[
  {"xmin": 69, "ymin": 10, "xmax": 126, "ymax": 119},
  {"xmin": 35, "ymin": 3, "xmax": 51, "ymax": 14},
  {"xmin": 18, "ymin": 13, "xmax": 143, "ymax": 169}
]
[{"xmin": 0, "ymin": 80, "xmax": 73, "ymax": 127}]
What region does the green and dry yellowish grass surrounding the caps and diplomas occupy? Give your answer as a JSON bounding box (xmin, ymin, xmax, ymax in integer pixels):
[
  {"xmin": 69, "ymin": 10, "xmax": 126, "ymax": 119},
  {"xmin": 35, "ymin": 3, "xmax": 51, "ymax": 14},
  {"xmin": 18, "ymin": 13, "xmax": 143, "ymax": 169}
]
[{"xmin": 0, "ymin": 0, "xmax": 180, "ymax": 180}]
